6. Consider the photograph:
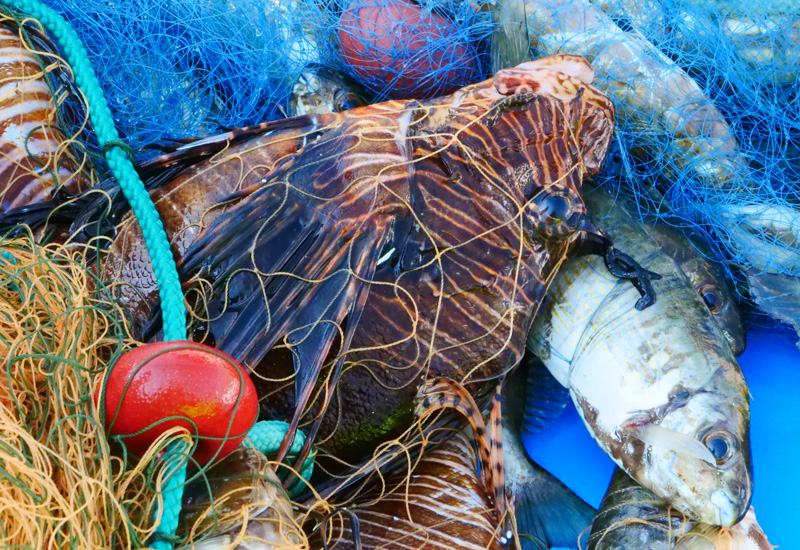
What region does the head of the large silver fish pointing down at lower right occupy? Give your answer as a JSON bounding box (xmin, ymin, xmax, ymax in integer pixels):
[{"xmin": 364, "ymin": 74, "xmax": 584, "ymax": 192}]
[{"xmin": 629, "ymin": 369, "xmax": 753, "ymax": 527}]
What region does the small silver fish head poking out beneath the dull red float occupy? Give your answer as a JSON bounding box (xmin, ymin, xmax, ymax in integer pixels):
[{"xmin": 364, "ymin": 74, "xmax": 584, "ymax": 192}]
[{"xmin": 288, "ymin": 64, "xmax": 369, "ymax": 116}]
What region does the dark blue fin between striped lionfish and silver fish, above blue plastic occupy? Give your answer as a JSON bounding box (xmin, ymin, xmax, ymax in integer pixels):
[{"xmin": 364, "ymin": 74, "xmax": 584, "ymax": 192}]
[{"xmin": 522, "ymin": 354, "xmax": 570, "ymax": 434}]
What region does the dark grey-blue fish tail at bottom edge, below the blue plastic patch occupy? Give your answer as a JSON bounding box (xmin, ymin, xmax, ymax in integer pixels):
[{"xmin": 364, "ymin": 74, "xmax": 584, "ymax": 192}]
[{"xmin": 514, "ymin": 464, "xmax": 596, "ymax": 550}]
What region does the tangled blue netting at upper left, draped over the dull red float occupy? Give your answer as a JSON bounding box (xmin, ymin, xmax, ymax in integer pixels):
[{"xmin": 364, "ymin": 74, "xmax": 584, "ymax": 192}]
[{"xmin": 46, "ymin": 0, "xmax": 491, "ymax": 153}]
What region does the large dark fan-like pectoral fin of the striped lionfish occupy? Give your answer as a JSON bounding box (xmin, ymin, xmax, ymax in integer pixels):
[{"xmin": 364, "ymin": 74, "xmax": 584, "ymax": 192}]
[{"xmin": 170, "ymin": 184, "xmax": 389, "ymax": 466}]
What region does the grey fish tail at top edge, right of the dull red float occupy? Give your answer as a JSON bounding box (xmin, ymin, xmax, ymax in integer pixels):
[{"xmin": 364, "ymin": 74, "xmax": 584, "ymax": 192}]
[{"xmin": 491, "ymin": 0, "xmax": 531, "ymax": 72}]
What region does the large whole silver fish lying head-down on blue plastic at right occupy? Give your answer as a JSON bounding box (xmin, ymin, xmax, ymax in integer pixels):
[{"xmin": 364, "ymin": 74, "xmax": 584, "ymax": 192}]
[{"xmin": 528, "ymin": 191, "xmax": 752, "ymax": 526}]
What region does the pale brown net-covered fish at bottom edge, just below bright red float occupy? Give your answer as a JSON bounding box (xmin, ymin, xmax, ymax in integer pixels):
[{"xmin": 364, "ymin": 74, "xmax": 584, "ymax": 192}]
[{"xmin": 179, "ymin": 446, "xmax": 308, "ymax": 550}]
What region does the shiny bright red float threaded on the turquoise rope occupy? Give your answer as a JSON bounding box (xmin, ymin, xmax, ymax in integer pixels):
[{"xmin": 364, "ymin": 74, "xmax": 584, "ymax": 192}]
[{"xmin": 96, "ymin": 342, "xmax": 258, "ymax": 465}]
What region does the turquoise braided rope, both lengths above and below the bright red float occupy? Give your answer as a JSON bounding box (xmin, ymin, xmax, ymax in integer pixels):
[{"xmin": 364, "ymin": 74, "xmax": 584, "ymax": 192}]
[{"xmin": 4, "ymin": 0, "xmax": 188, "ymax": 550}]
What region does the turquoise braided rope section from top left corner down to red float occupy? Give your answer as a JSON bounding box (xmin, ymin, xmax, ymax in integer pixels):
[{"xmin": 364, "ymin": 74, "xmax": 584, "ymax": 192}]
[{"xmin": 3, "ymin": 0, "xmax": 186, "ymax": 340}]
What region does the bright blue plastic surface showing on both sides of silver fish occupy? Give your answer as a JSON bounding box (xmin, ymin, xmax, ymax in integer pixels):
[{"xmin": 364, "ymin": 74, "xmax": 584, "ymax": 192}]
[{"xmin": 525, "ymin": 329, "xmax": 800, "ymax": 548}]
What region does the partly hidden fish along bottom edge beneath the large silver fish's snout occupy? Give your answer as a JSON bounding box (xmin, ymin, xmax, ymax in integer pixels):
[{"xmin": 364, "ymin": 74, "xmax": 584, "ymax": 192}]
[{"xmin": 588, "ymin": 468, "xmax": 776, "ymax": 550}]
